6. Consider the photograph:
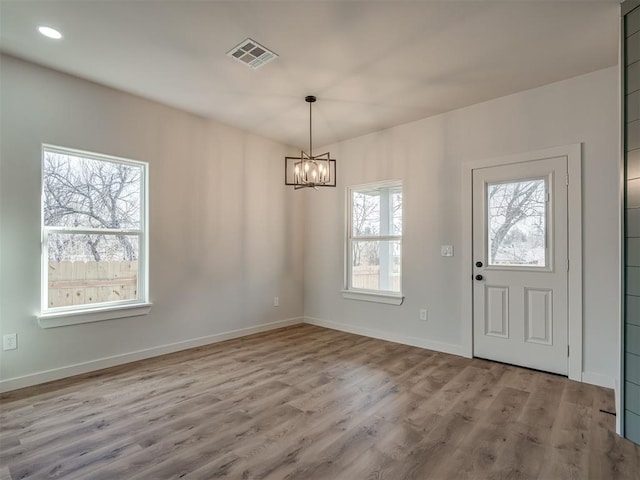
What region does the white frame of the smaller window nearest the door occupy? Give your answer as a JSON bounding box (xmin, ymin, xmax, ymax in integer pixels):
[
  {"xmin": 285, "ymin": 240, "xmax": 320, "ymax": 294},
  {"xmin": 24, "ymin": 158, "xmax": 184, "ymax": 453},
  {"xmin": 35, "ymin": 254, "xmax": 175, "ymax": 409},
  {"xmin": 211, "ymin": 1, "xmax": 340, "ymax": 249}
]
[{"xmin": 342, "ymin": 180, "xmax": 405, "ymax": 305}]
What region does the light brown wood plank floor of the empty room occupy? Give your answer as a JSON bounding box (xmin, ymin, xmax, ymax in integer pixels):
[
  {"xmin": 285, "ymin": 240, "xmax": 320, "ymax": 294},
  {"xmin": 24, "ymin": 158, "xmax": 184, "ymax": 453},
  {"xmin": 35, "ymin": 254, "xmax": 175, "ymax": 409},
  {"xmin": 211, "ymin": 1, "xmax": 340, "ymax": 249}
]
[{"xmin": 0, "ymin": 325, "xmax": 640, "ymax": 480}]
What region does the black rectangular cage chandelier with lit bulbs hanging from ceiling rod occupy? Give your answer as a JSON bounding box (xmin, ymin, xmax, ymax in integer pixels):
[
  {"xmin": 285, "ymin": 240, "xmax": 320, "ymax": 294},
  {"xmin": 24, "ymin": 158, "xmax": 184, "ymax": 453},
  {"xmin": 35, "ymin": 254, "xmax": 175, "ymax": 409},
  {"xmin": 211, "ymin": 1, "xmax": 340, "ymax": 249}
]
[{"xmin": 284, "ymin": 95, "xmax": 336, "ymax": 190}]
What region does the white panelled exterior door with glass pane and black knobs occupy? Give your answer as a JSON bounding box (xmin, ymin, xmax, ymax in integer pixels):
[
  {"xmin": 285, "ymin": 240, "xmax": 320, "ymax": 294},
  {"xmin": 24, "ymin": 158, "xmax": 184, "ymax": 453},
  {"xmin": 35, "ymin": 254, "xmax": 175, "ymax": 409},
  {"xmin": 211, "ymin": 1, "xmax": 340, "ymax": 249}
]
[{"xmin": 473, "ymin": 157, "xmax": 569, "ymax": 375}]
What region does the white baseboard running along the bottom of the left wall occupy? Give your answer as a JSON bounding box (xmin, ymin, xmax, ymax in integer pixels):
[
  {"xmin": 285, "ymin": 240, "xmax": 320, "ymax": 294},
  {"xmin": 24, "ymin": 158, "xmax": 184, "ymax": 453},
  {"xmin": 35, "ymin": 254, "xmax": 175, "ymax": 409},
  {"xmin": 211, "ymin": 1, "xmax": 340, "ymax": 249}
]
[{"xmin": 0, "ymin": 317, "xmax": 303, "ymax": 393}]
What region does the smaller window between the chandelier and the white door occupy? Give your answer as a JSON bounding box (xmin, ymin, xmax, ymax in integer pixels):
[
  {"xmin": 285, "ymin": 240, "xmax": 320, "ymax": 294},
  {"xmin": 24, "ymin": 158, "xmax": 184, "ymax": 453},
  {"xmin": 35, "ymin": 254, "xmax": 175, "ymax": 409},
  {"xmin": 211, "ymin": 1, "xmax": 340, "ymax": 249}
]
[{"xmin": 343, "ymin": 181, "xmax": 402, "ymax": 305}]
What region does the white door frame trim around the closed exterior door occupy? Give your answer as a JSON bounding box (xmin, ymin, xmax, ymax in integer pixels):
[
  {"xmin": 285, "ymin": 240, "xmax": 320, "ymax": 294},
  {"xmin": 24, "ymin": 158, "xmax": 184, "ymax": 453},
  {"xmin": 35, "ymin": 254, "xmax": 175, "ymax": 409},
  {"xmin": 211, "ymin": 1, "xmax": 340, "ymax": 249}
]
[{"xmin": 461, "ymin": 143, "xmax": 582, "ymax": 382}]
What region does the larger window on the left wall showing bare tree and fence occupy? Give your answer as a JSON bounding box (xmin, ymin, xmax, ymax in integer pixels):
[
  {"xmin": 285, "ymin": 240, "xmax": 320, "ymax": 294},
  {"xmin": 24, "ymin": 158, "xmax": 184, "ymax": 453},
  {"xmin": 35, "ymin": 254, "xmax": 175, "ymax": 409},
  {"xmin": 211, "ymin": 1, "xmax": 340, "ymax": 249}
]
[{"xmin": 40, "ymin": 145, "xmax": 148, "ymax": 326}]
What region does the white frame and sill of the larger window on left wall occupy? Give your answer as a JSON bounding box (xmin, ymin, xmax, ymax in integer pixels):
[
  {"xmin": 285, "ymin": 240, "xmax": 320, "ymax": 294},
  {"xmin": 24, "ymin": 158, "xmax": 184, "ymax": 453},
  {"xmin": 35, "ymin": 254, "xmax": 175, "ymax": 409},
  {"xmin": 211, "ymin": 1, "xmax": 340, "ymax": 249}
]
[{"xmin": 37, "ymin": 144, "xmax": 151, "ymax": 328}]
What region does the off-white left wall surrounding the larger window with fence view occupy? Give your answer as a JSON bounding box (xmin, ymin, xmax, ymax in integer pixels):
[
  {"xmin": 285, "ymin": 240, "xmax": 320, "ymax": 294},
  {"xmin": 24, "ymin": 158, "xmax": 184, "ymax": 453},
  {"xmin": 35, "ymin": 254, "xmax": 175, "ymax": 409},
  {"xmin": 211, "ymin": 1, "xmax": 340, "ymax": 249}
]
[{"xmin": 0, "ymin": 56, "xmax": 304, "ymax": 389}]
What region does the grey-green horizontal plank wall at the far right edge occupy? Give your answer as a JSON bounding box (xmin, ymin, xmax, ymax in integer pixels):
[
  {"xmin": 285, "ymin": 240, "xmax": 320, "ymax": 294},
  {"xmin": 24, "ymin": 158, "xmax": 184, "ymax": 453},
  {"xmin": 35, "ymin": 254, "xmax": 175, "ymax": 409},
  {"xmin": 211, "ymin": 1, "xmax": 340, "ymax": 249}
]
[{"xmin": 623, "ymin": 3, "xmax": 640, "ymax": 443}]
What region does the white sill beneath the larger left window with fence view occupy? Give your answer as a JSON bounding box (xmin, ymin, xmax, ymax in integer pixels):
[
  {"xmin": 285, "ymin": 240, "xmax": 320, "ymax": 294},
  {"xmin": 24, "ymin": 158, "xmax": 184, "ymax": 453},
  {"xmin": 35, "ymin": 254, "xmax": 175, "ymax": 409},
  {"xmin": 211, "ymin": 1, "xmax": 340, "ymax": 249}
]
[{"xmin": 38, "ymin": 303, "xmax": 151, "ymax": 328}]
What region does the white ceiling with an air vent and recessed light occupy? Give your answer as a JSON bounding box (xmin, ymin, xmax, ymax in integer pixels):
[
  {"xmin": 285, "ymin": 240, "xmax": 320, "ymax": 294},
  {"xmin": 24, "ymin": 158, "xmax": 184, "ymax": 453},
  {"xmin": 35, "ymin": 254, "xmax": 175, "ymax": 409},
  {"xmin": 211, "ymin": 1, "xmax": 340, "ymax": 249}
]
[{"xmin": 0, "ymin": 0, "xmax": 620, "ymax": 153}]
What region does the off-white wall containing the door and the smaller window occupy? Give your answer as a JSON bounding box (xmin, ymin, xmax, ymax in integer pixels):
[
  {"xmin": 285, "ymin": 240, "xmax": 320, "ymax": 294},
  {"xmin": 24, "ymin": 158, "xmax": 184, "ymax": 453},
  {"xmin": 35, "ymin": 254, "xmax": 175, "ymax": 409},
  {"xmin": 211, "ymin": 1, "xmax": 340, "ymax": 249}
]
[{"xmin": 304, "ymin": 67, "xmax": 620, "ymax": 386}]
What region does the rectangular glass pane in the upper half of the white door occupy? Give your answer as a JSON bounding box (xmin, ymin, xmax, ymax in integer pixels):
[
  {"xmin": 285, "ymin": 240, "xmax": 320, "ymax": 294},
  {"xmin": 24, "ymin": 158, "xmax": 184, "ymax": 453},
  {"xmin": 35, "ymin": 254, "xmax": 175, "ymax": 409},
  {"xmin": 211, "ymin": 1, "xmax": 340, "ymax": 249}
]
[{"xmin": 487, "ymin": 178, "xmax": 547, "ymax": 267}]
